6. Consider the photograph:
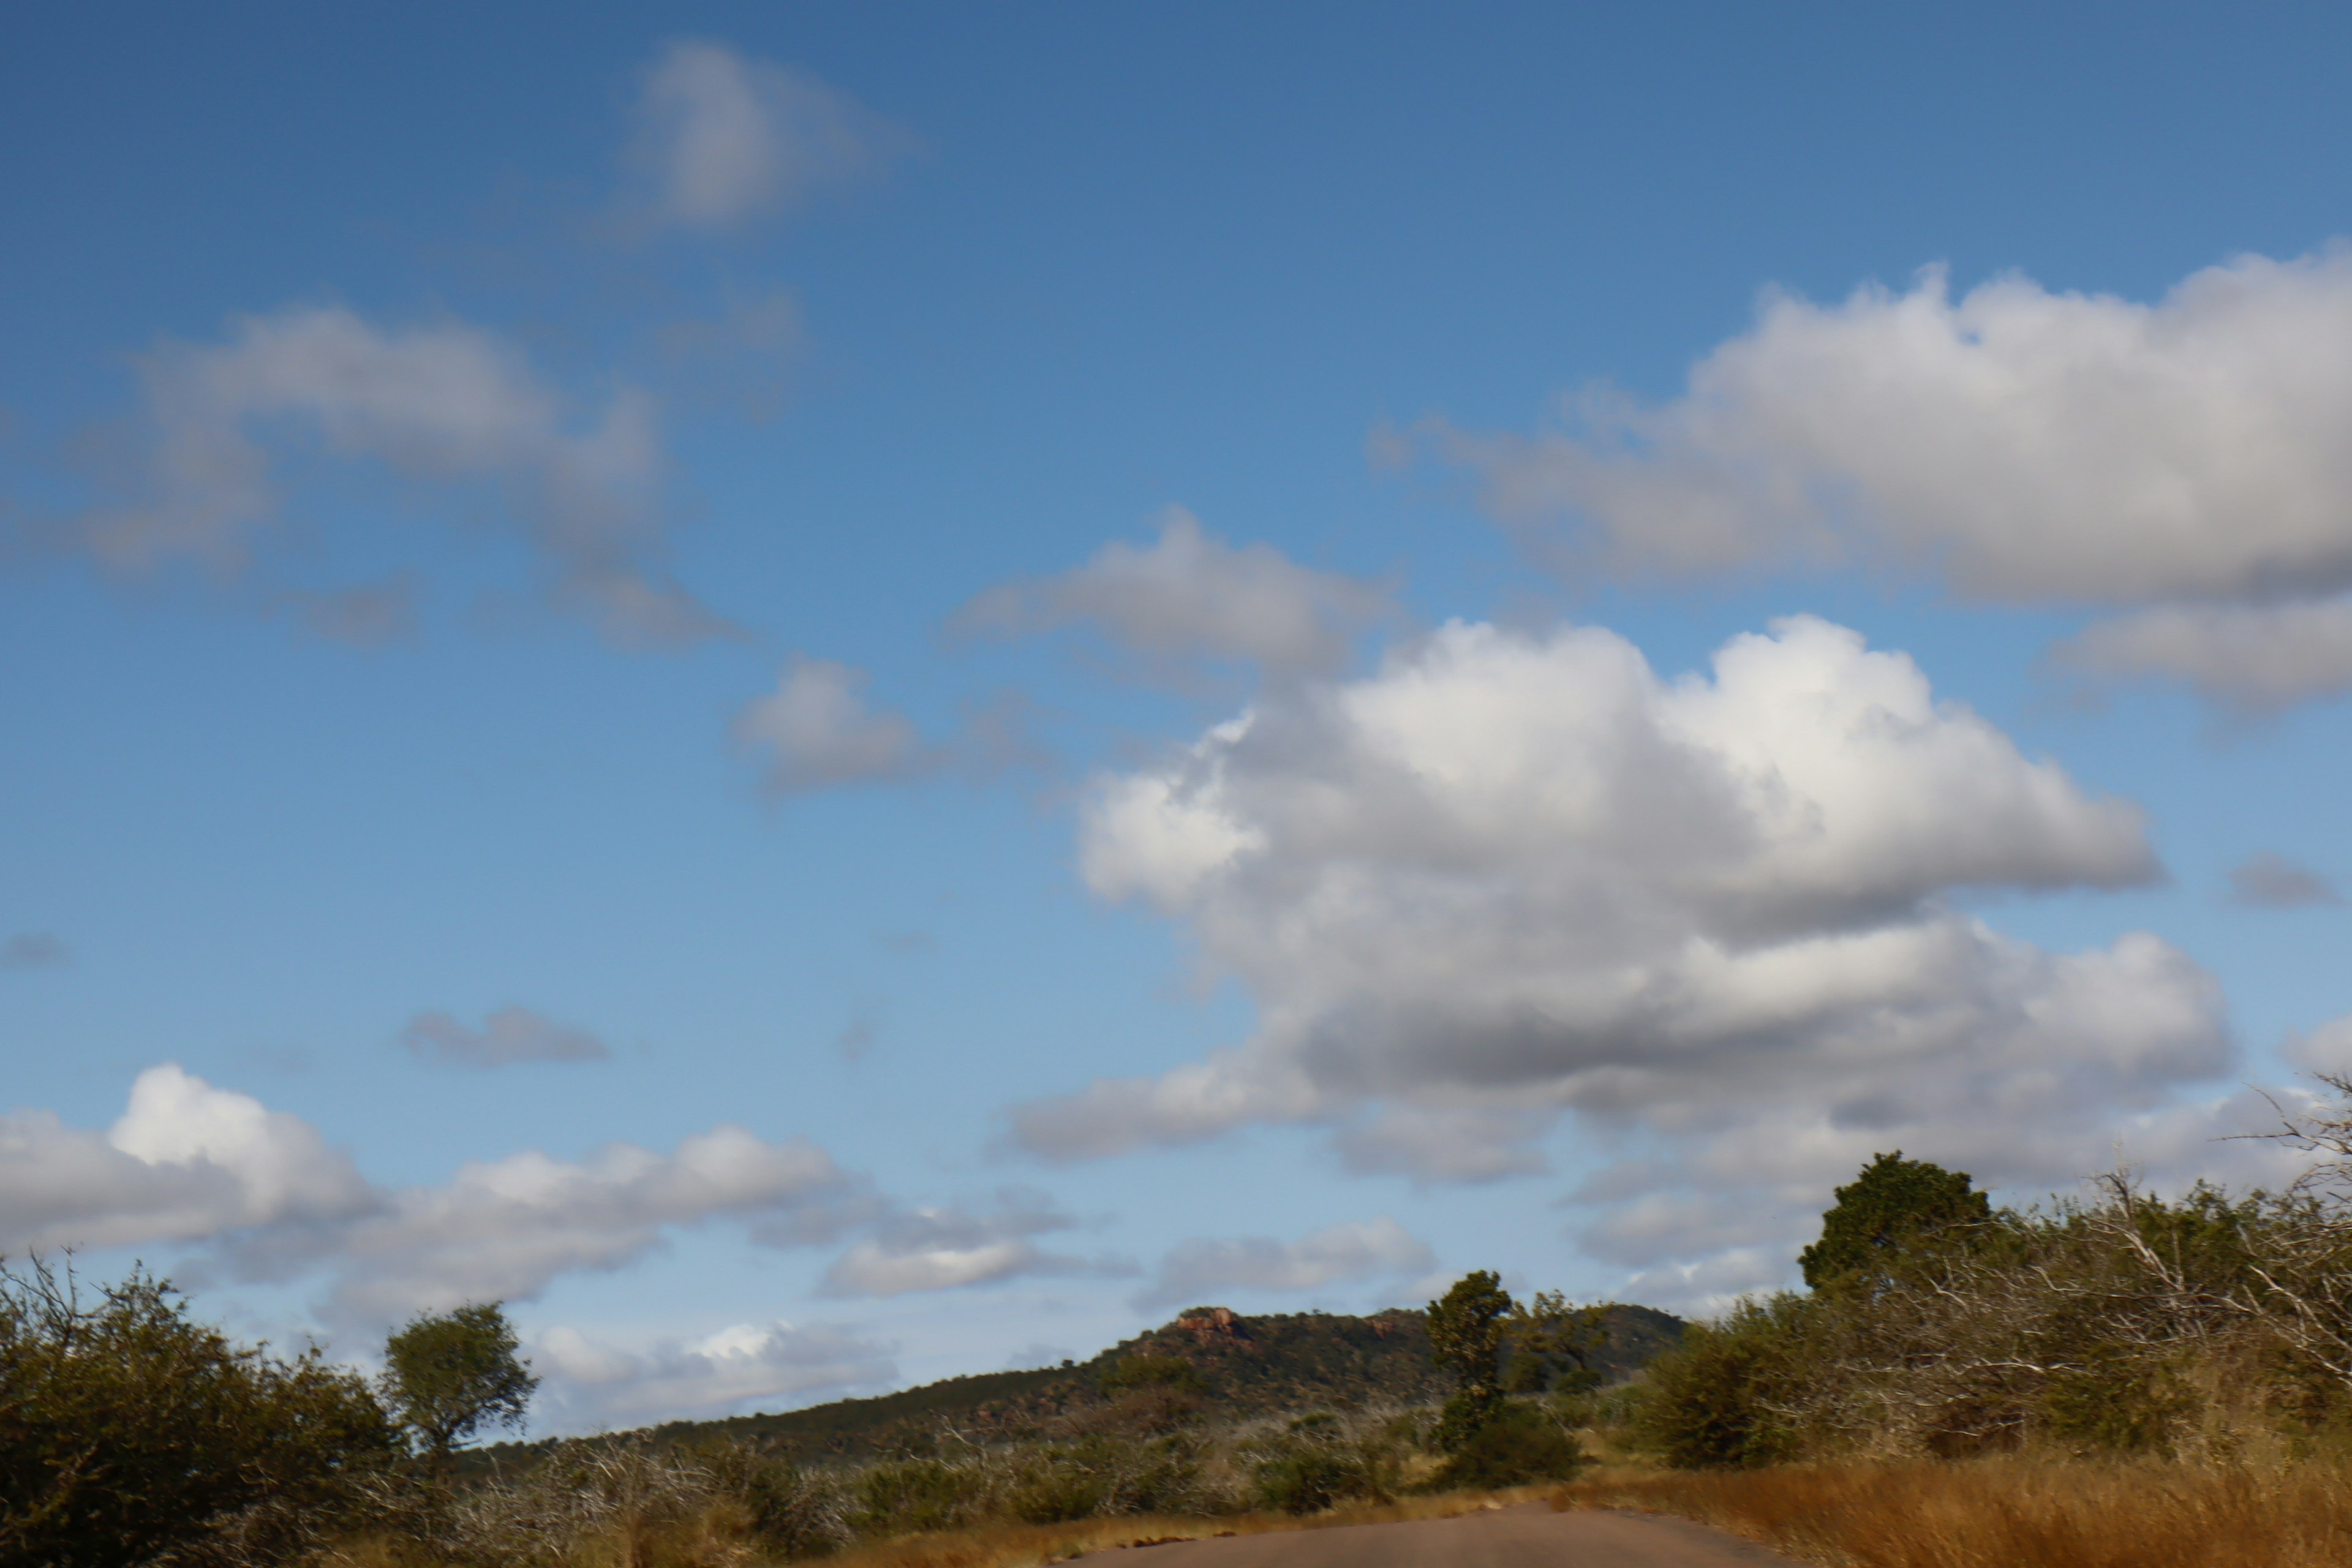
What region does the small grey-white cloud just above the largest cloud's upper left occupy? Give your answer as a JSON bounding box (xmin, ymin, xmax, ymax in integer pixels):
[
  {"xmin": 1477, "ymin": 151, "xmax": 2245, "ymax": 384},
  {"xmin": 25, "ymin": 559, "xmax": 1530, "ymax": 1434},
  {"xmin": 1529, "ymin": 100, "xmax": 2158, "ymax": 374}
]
[{"xmin": 957, "ymin": 505, "xmax": 1397, "ymax": 673}]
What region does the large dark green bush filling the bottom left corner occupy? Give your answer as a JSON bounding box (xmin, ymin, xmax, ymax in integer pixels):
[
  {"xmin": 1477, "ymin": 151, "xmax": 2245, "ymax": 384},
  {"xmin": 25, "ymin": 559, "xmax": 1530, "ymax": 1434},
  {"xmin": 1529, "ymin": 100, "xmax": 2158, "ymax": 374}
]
[{"xmin": 0, "ymin": 1260, "xmax": 398, "ymax": 1568}]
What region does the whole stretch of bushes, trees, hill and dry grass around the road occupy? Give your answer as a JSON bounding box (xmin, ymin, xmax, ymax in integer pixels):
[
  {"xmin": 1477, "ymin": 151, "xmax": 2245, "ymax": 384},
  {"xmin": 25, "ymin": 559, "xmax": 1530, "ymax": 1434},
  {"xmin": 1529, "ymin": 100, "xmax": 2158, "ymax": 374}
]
[{"xmin": 13, "ymin": 1079, "xmax": 2352, "ymax": 1568}]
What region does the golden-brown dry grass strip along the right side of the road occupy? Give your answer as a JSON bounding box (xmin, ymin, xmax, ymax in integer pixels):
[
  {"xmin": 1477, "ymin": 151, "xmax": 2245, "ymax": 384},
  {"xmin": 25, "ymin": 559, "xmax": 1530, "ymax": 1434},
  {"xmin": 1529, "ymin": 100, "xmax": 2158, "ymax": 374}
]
[{"xmin": 1552, "ymin": 1460, "xmax": 2352, "ymax": 1568}]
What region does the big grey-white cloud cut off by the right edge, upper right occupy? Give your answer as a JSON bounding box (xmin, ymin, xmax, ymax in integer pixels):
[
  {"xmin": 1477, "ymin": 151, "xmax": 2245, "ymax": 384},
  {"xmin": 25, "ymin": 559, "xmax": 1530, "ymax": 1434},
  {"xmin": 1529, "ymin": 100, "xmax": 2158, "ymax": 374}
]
[{"xmin": 1428, "ymin": 249, "xmax": 2352, "ymax": 705}]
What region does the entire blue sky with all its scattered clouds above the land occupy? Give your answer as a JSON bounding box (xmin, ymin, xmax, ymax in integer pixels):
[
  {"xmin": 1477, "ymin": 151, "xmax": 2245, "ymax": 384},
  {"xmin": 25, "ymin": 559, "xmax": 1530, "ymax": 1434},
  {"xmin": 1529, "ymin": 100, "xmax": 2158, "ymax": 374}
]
[{"xmin": 0, "ymin": 5, "xmax": 2352, "ymax": 1430}]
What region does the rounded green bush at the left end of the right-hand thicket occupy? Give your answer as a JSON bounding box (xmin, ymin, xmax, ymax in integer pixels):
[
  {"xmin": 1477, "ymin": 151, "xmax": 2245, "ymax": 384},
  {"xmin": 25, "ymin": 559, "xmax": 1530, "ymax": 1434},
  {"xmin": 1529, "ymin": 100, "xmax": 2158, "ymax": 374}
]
[{"xmin": 1639, "ymin": 1295, "xmax": 1806, "ymax": 1469}]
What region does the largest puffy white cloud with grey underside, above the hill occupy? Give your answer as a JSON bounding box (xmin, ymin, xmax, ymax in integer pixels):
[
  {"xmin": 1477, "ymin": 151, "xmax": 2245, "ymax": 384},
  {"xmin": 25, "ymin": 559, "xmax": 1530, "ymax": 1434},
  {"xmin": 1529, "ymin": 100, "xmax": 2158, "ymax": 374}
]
[{"xmin": 1014, "ymin": 618, "xmax": 2232, "ymax": 1297}]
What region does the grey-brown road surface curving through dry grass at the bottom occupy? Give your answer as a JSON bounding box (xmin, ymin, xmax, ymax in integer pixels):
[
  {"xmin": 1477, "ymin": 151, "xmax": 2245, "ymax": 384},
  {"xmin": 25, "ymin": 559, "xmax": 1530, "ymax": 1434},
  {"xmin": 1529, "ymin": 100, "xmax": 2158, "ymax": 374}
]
[{"xmin": 1084, "ymin": 1502, "xmax": 1795, "ymax": 1568}]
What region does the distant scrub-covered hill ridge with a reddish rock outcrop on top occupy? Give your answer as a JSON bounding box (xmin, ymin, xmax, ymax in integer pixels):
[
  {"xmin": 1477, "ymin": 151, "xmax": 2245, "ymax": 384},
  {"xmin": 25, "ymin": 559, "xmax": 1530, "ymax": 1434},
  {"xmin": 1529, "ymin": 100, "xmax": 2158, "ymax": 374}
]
[{"xmin": 588, "ymin": 1305, "xmax": 1684, "ymax": 1462}]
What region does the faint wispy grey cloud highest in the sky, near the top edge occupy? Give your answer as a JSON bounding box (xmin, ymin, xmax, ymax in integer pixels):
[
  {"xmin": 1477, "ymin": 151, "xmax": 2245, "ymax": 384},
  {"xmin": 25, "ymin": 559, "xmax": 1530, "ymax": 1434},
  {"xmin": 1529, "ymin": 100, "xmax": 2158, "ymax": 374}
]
[{"xmin": 628, "ymin": 37, "xmax": 908, "ymax": 228}]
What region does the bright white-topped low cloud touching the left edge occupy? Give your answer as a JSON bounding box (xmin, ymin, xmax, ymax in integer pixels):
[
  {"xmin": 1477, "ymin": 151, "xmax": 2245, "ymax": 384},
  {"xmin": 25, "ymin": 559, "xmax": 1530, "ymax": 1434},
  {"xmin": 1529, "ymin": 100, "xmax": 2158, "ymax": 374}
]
[{"xmin": 0, "ymin": 1063, "xmax": 376, "ymax": 1256}]
